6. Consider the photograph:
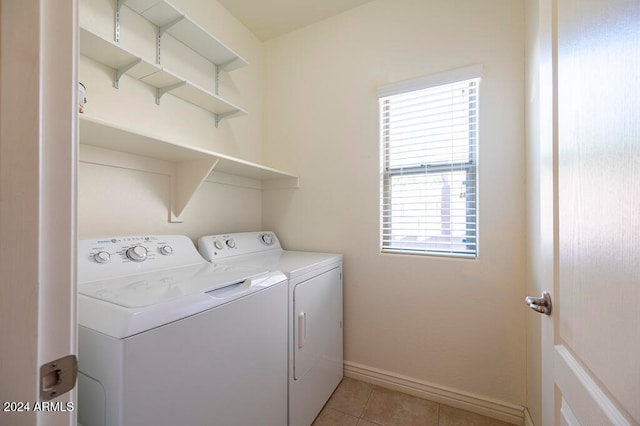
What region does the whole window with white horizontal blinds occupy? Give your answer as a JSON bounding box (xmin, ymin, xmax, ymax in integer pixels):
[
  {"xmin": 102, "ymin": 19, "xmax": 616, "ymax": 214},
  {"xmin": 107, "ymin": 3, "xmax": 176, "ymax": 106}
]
[{"xmin": 379, "ymin": 66, "xmax": 481, "ymax": 257}]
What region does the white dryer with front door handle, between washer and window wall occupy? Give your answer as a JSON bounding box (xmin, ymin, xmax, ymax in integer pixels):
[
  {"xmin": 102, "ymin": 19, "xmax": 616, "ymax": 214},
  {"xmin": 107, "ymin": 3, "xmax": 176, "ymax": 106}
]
[{"xmin": 198, "ymin": 232, "xmax": 343, "ymax": 426}]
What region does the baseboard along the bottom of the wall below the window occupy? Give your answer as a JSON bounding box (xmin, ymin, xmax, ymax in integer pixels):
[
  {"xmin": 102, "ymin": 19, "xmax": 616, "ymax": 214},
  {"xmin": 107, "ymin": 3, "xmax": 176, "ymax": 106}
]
[{"xmin": 344, "ymin": 361, "xmax": 525, "ymax": 425}]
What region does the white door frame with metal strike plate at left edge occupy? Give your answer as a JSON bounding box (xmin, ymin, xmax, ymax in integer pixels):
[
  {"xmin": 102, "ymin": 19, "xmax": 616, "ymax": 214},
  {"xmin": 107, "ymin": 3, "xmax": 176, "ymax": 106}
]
[{"xmin": 0, "ymin": 0, "xmax": 77, "ymax": 426}]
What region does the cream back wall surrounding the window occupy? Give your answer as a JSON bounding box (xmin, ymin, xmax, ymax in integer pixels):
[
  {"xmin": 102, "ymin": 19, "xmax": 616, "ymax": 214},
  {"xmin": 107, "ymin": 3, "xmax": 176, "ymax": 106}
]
[{"xmin": 263, "ymin": 0, "xmax": 526, "ymax": 420}]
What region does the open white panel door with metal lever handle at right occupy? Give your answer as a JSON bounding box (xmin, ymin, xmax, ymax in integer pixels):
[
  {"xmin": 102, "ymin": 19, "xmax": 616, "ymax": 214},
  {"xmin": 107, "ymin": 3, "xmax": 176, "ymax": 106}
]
[{"xmin": 542, "ymin": 0, "xmax": 640, "ymax": 425}]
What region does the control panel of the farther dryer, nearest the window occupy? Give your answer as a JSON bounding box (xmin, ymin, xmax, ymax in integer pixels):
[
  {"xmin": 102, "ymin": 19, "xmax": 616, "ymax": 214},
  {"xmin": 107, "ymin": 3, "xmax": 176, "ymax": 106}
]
[{"xmin": 198, "ymin": 232, "xmax": 281, "ymax": 260}]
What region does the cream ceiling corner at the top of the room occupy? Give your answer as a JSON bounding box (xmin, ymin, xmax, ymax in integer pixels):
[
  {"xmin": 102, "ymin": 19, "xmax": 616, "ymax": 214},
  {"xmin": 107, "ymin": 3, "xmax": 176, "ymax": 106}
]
[{"xmin": 218, "ymin": 0, "xmax": 371, "ymax": 41}]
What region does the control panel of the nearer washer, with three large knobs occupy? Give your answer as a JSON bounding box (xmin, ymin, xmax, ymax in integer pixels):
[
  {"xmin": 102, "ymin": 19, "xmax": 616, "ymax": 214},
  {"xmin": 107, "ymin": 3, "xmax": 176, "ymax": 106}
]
[{"xmin": 78, "ymin": 235, "xmax": 204, "ymax": 282}]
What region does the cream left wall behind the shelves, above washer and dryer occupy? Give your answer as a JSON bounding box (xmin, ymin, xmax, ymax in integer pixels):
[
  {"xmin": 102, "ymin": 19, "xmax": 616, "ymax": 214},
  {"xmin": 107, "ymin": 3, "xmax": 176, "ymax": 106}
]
[{"xmin": 78, "ymin": 0, "xmax": 263, "ymax": 239}]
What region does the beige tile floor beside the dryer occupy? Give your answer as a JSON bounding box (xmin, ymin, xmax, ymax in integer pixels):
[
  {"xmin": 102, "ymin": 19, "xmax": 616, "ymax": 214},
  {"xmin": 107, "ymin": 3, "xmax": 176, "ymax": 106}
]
[{"xmin": 312, "ymin": 377, "xmax": 508, "ymax": 426}]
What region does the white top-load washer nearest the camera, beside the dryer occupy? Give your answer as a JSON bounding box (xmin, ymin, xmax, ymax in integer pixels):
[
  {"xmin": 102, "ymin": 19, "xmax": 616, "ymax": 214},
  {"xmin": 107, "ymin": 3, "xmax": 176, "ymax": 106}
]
[{"xmin": 78, "ymin": 235, "xmax": 288, "ymax": 426}]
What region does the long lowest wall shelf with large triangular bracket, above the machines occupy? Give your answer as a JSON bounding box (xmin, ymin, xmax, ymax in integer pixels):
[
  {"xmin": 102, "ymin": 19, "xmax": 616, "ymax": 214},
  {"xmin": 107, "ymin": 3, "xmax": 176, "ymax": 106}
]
[{"xmin": 80, "ymin": 114, "xmax": 299, "ymax": 222}]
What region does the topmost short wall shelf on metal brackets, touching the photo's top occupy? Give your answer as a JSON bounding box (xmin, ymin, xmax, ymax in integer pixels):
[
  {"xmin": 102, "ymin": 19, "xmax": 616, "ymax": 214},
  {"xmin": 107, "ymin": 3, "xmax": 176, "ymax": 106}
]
[{"xmin": 118, "ymin": 0, "xmax": 249, "ymax": 71}]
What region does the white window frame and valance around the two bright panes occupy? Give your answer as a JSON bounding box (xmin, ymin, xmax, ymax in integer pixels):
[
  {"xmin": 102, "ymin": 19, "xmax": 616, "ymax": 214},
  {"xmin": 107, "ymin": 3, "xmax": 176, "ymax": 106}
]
[{"xmin": 378, "ymin": 65, "xmax": 482, "ymax": 259}]
